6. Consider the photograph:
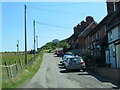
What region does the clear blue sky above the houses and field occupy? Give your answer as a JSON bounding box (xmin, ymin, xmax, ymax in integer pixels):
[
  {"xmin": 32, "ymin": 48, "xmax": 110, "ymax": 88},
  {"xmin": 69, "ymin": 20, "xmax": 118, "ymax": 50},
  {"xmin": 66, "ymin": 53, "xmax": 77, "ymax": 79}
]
[{"xmin": 2, "ymin": 2, "xmax": 107, "ymax": 51}]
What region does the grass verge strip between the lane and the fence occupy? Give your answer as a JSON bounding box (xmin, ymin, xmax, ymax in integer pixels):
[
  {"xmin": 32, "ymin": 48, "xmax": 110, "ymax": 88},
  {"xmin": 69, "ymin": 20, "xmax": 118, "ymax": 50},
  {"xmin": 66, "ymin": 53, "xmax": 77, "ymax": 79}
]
[{"xmin": 2, "ymin": 52, "xmax": 43, "ymax": 88}]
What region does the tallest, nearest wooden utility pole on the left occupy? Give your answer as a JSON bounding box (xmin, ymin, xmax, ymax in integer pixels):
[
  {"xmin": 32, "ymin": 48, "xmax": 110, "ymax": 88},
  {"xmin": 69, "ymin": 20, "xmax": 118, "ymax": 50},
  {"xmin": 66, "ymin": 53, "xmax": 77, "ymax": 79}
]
[{"xmin": 24, "ymin": 5, "xmax": 27, "ymax": 68}]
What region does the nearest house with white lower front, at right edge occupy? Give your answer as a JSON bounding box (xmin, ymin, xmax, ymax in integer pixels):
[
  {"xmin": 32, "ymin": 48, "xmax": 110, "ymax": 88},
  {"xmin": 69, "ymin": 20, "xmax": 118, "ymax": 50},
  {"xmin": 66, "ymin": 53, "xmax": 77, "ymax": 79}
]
[{"xmin": 106, "ymin": 1, "xmax": 120, "ymax": 68}]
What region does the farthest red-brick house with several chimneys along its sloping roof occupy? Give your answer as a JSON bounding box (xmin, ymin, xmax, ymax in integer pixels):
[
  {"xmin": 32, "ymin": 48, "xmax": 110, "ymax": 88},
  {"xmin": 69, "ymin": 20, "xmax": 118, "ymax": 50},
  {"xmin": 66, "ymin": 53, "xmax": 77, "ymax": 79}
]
[{"xmin": 68, "ymin": 16, "xmax": 97, "ymax": 55}]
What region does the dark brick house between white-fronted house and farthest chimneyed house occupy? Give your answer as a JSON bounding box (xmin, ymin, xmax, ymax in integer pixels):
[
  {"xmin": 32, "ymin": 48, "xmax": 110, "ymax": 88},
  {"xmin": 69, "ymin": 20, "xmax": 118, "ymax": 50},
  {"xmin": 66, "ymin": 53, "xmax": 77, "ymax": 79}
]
[{"xmin": 88, "ymin": 15, "xmax": 109, "ymax": 66}]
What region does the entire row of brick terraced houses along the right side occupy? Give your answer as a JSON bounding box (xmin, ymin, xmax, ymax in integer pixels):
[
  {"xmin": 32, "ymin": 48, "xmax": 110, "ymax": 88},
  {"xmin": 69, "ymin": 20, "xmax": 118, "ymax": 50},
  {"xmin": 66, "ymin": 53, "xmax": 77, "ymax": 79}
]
[{"xmin": 69, "ymin": 0, "xmax": 120, "ymax": 68}]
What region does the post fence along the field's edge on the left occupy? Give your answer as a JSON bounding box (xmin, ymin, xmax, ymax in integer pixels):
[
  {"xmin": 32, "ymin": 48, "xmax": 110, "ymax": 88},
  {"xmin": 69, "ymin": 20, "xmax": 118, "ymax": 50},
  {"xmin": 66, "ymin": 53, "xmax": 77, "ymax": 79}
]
[{"xmin": 0, "ymin": 54, "xmax": 38, "ymax": 81}]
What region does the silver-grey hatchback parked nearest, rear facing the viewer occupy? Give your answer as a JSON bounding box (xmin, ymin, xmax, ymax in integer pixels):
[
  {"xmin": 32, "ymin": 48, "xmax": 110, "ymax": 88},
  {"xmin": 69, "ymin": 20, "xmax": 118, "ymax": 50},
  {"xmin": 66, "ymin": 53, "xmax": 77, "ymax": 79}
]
[{"xmin": 65, "ymin": 57, "xmax": 86, "ymax": 71}]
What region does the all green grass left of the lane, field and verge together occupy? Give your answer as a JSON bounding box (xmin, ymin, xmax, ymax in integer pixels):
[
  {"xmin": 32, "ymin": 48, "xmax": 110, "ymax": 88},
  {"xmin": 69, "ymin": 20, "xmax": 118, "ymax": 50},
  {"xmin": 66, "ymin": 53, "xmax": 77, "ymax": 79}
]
[{"xmin": 2, "ymin": 52, "xmax": 43, "ymax": 88}]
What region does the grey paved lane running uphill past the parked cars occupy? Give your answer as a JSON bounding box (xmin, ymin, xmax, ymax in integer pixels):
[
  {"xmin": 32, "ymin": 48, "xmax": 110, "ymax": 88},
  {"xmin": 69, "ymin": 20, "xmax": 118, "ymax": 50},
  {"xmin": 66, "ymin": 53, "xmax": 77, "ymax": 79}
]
[{"xmin": 20, "ymin": 53, "xmax": 117, "ymax": 88}]
